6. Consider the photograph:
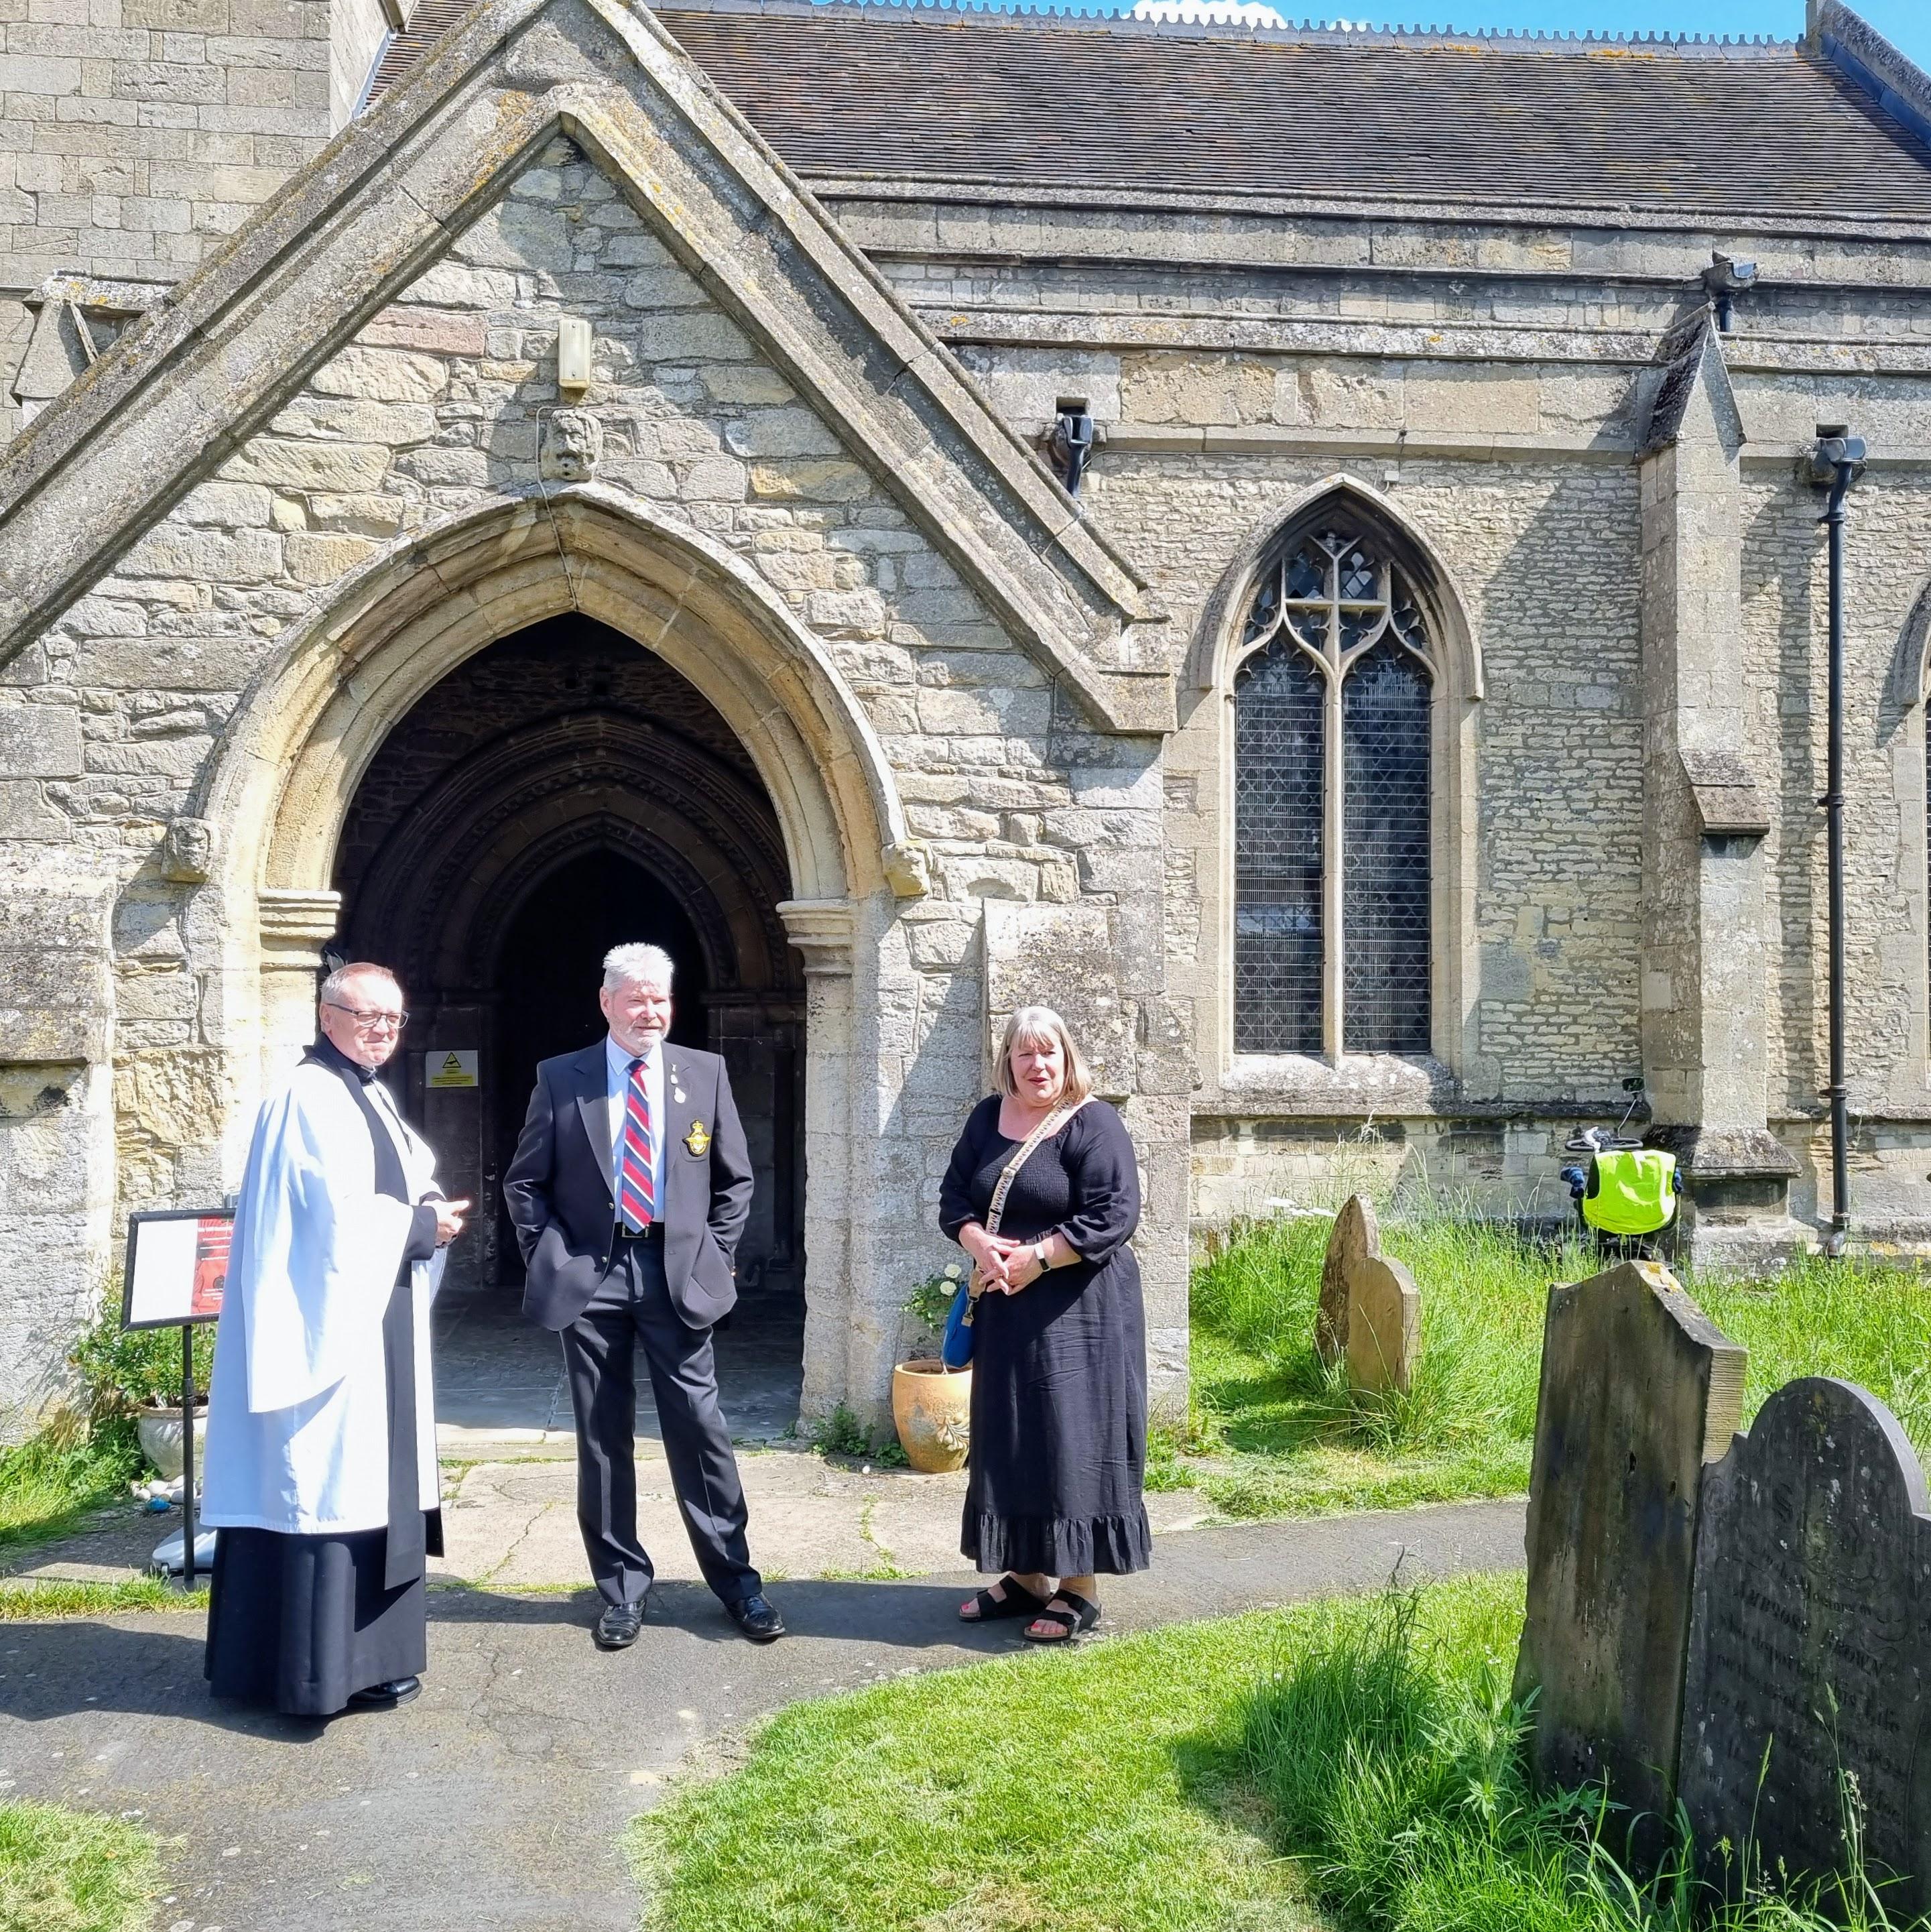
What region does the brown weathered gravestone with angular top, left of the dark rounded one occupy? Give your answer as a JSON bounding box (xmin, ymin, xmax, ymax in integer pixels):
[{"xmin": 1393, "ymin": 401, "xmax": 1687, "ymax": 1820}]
[{"xmin": 1516, "ymin": 1262, "xmax": 1745, "ymax": 1829}]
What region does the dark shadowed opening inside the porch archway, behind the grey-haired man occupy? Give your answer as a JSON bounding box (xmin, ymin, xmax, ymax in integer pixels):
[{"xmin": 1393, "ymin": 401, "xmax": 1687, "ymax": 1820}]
[{"xmin": 330, "ymin": 613, "xmax": 805, "ymax": 1433}]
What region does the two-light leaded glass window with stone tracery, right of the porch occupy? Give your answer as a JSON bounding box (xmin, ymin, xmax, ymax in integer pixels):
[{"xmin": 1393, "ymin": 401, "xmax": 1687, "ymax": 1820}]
[{"xmin": 1234, "ymin": 520, "xmax": 1435, "ymax": 1056}]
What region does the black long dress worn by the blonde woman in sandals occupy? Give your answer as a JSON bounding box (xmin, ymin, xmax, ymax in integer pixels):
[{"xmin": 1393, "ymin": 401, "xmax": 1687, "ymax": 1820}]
[{"xmin": 938, "ymin": 1093, "xmax": 1153, "ymax": 1577}]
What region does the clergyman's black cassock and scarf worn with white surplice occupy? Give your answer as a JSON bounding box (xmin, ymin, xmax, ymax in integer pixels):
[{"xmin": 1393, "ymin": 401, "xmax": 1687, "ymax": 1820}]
[{"xmin": 206, "ymin": 1040, "xmax": 442, "ymax": 1717}]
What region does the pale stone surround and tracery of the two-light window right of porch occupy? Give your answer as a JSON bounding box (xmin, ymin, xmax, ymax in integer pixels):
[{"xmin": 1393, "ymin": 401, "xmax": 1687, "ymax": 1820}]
[{"xmin": 1192, "ymin": 475, "xmax": 1483, "ymax": 1091}]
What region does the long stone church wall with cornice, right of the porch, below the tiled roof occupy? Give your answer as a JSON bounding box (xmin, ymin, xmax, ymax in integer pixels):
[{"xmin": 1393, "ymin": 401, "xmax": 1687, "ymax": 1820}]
[{"xmin": 930, "ymin": 189, "xmax": 1931, "ymax": 1233}]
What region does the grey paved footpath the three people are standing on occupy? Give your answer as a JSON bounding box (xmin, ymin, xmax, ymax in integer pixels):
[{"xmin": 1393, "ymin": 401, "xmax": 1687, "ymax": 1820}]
[{"xmin": 0, "ymin": 1455, "xmax": 1523, "ymax": 1932}]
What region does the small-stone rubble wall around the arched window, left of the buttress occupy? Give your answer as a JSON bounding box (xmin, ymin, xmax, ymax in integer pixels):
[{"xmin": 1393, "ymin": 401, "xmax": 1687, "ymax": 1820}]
[{"xmin": 1093, "ymin": 442, "xmax": 1641, "ymax": 1099}]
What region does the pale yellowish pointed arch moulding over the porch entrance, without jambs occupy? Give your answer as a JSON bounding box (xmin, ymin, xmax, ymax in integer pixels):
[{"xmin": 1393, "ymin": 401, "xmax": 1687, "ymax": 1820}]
[{"xmin": 195, "ymin": 485, "xmax": 923, "ymax": 1073}]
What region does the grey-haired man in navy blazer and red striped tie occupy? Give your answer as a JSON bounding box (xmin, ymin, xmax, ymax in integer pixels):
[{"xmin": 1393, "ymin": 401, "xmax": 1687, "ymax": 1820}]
[{"xmin": 502, "ymin": 947, "xmax": 784, "ymax": 1650}]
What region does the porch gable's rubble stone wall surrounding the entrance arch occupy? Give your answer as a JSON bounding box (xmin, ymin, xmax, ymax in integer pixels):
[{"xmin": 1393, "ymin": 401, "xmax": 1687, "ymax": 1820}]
[{"xmin": 0, "ymin": 141, "xmax": 1184, "ymax": 1406}]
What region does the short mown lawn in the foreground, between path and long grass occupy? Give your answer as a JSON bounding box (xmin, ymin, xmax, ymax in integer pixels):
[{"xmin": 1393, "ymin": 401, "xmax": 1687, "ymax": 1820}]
[{"xmin": 633, "ymin": 1615, "xmax": 1319, "ymax": 1932}]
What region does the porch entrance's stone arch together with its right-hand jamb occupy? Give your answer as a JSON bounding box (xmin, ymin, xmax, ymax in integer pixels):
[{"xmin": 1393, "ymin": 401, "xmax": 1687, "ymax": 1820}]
[{"xmin": 181, "ymin": 485, "xmax": 925, "ymax": 1412}]
